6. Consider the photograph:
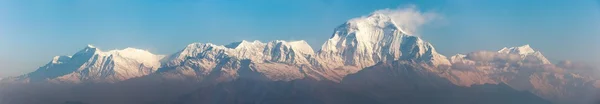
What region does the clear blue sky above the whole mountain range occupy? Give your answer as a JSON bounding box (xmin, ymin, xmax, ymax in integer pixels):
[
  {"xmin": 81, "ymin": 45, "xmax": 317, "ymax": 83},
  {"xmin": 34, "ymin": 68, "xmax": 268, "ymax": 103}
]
[{"xmin": 0, "ymin": 0, "xmax": 600, "ymax": 77}]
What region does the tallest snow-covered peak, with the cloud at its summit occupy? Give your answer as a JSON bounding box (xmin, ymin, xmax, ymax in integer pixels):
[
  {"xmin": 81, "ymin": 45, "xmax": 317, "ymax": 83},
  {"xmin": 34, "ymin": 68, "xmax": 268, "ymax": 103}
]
[{"xmin": 319, "ymin": 12, "xmax": 449, "ymax": 68}]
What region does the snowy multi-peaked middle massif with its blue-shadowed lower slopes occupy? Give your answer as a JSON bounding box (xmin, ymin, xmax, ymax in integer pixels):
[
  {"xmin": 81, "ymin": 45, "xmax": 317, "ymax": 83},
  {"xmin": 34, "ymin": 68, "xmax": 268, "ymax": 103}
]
[{"xmin": 162, "ymin": 40, "xmax": 314, "ymax": 81}]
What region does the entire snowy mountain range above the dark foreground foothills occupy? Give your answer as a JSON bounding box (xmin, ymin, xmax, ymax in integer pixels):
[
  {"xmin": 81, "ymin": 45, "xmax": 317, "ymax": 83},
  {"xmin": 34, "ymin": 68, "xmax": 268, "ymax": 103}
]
[{"xmin": 4, "ymin": 12, "xmax": 599, "ymax": 103}]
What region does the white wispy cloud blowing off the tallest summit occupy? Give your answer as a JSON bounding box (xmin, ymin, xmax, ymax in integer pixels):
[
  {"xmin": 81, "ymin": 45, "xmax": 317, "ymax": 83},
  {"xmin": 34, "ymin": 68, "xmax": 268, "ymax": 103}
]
[{"xmin": 375, "ymin": 5, "xmax": 439, "ymax": 35}]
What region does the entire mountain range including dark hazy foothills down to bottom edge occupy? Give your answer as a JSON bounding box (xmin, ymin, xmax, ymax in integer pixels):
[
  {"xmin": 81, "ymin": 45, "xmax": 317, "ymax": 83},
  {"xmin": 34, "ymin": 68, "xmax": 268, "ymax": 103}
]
[{"xmin": 0, "ymin": 9, "xmax": 600, "ymax": 104}]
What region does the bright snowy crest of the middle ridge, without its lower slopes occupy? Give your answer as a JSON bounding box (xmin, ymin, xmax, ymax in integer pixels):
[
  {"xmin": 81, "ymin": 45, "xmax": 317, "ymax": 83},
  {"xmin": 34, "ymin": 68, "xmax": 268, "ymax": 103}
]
[{"xmin": 168, "ymin": 40, "xmax": 314, "ymax": 66}]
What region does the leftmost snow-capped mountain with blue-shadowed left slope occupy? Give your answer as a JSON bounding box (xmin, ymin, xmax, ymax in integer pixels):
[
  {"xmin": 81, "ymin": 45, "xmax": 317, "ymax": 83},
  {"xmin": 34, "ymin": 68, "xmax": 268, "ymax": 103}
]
[{"xmin": 15, "ymin": 45, "xmax": 163, "ymax": 83}]
